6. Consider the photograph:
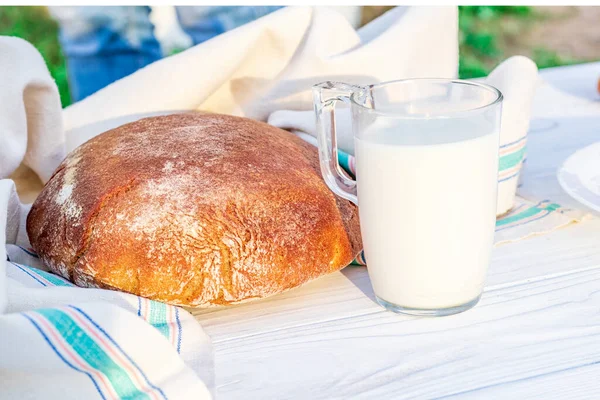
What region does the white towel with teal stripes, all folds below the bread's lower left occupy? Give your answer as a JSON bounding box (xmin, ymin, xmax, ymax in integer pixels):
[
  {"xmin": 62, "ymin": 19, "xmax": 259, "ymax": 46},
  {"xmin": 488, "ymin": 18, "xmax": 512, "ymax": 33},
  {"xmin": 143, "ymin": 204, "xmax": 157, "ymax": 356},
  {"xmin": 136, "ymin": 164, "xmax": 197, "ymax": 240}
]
[{"xmin": 0, "ymin": 252, "xmax": 214, "ymax": 399}]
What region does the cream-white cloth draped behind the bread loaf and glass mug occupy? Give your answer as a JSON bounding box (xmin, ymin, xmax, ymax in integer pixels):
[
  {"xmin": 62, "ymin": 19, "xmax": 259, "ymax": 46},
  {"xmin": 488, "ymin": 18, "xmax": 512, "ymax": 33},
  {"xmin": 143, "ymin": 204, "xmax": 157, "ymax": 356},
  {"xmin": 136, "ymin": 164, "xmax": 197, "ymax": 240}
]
[{"xmin": 64, "ymin": 7, "xmax": 458, "ymax": 130}]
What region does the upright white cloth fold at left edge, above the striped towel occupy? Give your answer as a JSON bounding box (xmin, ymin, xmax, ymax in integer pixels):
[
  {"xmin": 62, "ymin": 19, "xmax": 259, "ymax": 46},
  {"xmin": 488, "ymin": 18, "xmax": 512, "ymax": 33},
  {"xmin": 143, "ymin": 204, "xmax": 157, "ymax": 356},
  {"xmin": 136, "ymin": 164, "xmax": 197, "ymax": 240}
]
[{"xmin": 0, "ymin": 37, "xmax": 65, "ymax": 182}]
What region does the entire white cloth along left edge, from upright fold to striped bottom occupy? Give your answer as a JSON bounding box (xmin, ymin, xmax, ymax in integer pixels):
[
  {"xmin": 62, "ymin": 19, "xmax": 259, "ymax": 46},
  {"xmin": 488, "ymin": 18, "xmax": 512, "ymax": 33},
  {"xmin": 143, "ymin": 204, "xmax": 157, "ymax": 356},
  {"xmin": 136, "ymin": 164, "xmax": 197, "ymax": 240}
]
[{"xmin": 0, "ymin": 37, "xmax": 214, "ymax": 399}]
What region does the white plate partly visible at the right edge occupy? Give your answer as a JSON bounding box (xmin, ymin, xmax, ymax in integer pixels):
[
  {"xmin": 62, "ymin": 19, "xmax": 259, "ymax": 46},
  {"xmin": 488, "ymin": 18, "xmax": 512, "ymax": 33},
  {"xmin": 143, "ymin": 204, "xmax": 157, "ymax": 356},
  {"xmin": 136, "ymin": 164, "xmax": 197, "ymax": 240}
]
[{"xmin": 557, "ymin": 142, "xmax": 600, "ymax": 212}]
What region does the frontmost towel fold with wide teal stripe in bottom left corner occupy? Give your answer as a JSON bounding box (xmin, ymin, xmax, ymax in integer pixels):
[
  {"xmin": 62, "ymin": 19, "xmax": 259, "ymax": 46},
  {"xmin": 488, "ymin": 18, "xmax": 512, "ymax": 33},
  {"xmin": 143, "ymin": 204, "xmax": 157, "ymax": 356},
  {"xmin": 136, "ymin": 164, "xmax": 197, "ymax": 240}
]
[{"xmin": 0, "ymin": 302, "xmax": 210, "ymax": 399}]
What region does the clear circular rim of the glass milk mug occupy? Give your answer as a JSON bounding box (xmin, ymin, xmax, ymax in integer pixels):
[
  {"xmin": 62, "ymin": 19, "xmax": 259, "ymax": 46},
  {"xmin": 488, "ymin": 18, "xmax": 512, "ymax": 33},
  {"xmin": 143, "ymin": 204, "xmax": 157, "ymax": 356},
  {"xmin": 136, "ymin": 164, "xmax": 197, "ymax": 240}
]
[{"xmin": 350, "ymin": 78, "xmax": 504, "ymax": 119}]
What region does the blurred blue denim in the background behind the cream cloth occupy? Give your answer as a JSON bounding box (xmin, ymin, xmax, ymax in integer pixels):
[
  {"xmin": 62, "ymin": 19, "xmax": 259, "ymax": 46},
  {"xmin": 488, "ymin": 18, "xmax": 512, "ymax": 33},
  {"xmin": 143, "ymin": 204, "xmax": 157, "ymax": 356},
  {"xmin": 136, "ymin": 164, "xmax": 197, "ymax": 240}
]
[{"xmin": 50, "ymin": 6, "xmax": 282, "ymax": 101}]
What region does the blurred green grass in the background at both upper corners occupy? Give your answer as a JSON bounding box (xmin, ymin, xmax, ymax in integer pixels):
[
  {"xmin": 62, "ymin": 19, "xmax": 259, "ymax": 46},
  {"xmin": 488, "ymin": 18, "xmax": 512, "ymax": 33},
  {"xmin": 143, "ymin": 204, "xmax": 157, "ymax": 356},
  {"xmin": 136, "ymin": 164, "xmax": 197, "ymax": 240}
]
[{"xmin": 0, "ymin": 6, "xmax": 579, "ymax": 106}]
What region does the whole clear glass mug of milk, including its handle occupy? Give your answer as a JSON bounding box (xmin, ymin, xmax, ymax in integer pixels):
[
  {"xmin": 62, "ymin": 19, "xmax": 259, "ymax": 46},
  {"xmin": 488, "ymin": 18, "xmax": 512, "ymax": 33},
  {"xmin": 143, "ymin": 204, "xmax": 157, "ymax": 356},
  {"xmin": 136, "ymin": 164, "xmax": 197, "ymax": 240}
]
[{"xmin": 313, "ymin": 79, "xmax": 502, "ymax": 316}]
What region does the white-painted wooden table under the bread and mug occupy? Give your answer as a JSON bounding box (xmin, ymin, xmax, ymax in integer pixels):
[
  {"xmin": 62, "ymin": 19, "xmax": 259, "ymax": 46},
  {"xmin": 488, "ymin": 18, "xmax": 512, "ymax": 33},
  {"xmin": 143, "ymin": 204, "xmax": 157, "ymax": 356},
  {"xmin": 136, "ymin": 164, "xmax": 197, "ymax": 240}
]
[{"xmin": 196, "ymin": 63, "xmax": 600, "ymax": 399}]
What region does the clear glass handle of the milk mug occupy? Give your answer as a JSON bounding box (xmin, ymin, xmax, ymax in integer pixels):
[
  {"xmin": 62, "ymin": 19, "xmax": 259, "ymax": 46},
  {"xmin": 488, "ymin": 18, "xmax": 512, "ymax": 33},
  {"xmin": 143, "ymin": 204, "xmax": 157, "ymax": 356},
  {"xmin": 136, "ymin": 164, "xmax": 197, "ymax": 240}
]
[{"xmin": 313, "ymin": 82, "xmax": 363, "ymax": 205}]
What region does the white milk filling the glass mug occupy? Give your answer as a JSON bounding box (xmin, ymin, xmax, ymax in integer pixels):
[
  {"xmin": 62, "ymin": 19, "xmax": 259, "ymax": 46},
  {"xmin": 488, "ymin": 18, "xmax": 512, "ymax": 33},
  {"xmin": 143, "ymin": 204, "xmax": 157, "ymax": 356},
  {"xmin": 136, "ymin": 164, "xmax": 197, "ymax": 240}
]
[{"xmin": 355, "ymin": 117, "xmax": 498, "ymax": 309}]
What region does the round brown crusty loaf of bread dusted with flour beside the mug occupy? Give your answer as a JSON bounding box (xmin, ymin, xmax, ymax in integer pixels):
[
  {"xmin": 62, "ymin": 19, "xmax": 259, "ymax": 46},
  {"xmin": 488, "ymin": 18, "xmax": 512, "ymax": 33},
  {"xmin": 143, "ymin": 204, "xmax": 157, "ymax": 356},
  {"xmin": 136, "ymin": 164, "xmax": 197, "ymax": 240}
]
[{"xmin": 27, "ymin": 113, "xmax": 361, "ymax": 306}]
